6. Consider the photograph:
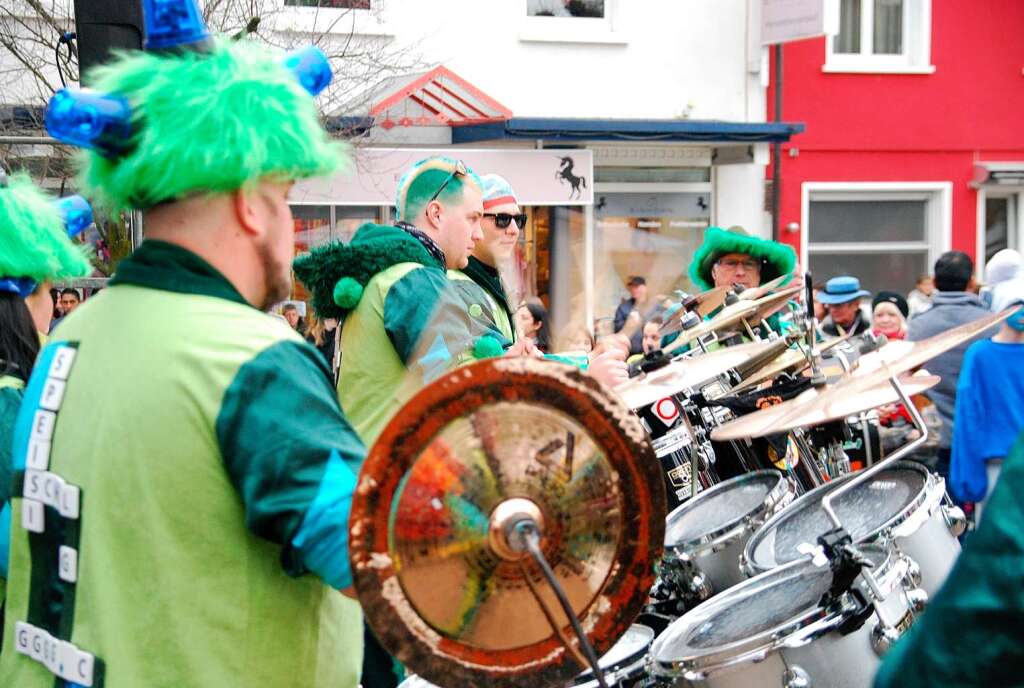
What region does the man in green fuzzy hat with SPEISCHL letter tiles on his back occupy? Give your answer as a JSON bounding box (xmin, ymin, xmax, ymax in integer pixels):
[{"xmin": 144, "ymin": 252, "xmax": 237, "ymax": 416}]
[{"xmin": 0, "ymin": 2, "xmax": 365, "ymax": 688}]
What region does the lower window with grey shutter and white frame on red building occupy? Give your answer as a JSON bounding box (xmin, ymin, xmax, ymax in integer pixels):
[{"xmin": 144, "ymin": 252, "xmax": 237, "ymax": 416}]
[{"xmin": 805, "ymin": 184, "xmax": 951, "ymax": 294}]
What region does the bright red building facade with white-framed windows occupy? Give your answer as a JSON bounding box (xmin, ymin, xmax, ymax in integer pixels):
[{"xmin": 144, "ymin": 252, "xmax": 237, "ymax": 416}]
[{"xmin": 768, "ymin": 0, "xmax": 1024, "ymax": 292}]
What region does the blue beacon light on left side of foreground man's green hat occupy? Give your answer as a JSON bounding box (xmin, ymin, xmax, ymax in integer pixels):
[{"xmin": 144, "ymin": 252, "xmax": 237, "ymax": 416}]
[{"xmin": 44, "ymin": 88, "xmax": 132, "ymax": 158}]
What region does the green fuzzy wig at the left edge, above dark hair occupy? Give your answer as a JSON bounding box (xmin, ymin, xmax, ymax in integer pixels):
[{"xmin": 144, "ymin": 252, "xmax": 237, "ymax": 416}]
[{"xmin": 0, "ymin": 174, "xmax": 92, "ymax": 282}]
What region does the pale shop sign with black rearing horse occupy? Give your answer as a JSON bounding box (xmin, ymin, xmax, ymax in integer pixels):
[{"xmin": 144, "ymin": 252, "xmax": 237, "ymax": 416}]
[{"xmin": 289, "ymin": 148, "xmax": 594, "ymax": 206}]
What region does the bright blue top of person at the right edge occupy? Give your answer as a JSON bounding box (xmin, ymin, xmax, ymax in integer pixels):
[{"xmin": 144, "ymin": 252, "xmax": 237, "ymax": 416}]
[{"xmin": 949, "ymin": 340, "xmax": 1024, "ymax": 502}]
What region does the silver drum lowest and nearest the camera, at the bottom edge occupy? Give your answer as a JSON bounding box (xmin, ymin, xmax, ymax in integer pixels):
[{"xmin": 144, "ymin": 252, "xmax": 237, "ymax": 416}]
[{"xmin": 648, "ymin": 546, "xmax": 912, "ymax": 688}]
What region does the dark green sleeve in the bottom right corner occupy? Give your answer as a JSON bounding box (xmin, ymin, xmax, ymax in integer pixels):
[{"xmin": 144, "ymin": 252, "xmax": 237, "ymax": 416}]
[{"xmin": 874, "ymin": 435, "xmax": 1024, "ymax": 688}]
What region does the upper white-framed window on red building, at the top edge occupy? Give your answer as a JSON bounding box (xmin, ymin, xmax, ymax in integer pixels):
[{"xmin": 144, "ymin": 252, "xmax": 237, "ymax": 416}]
[{"xmin": 824, "ymin": 0, "xmax": 935, "ymax": 74}]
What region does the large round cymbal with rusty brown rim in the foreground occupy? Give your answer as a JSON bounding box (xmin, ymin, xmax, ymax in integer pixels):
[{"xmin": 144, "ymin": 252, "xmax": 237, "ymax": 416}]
[{"xmin": 349, "ymin": 358, "xmax": 666, "ymax": 688}]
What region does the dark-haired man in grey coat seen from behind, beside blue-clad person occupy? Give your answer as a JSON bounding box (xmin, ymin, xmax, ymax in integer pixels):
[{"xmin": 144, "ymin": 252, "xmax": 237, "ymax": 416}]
[{"xmin": 906, "ymin": 251, "xmax": 998, "ymax": 479}]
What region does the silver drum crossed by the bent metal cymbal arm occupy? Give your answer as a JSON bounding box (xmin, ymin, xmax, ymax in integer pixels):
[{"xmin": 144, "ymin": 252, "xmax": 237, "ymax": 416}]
[{"xmin": 742, "ymin": 462, "xmax": 961, "ymax": 595}]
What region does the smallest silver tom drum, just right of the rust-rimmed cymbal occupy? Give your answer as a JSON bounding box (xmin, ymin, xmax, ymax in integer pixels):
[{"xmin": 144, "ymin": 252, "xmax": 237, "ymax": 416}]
[{"xmin": 665, "ymin": 470, "xmax": 795, "ymax": 593}]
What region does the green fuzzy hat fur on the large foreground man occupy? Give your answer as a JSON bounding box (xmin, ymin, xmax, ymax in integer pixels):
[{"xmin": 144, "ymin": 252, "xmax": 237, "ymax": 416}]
[{"xmin": 80, "ymin": 39, "xmax": 347, "ymax": 211}]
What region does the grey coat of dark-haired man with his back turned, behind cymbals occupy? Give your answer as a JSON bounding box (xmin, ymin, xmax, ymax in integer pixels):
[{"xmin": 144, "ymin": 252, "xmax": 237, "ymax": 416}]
[{"xmin": 906, "ymin": 292, "xmax": 999, "ymax": 448}]
